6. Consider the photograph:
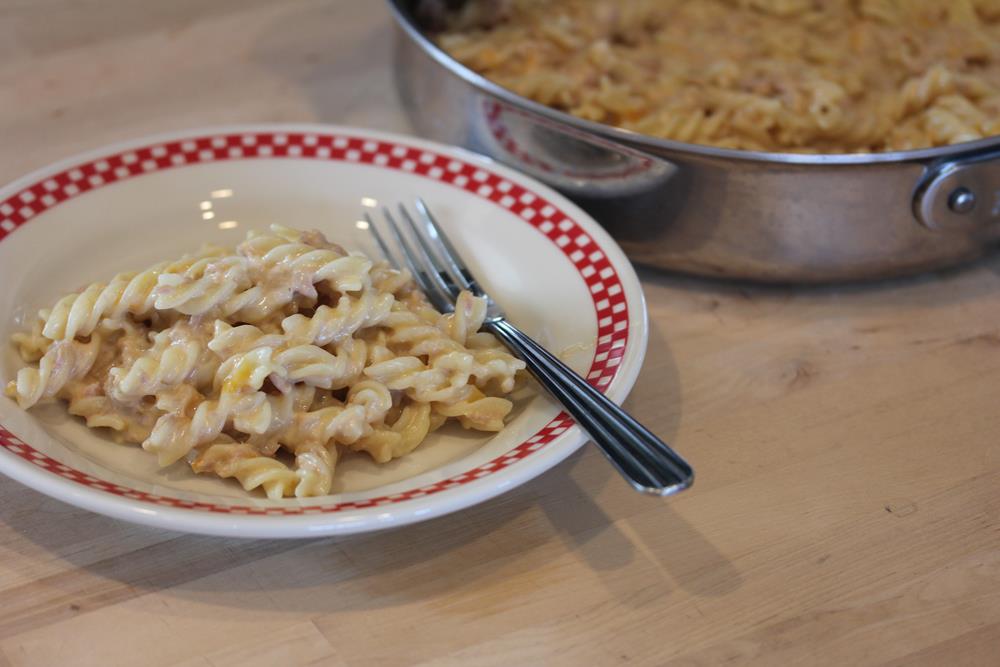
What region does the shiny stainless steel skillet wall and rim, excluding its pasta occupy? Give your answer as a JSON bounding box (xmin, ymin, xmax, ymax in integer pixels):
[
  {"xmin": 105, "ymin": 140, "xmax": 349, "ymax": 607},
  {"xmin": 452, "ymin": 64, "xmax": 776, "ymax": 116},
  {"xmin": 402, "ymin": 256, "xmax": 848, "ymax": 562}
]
[{"xmin": 388, "ymin": 0, "xmax": 1000, "ymax": 282}]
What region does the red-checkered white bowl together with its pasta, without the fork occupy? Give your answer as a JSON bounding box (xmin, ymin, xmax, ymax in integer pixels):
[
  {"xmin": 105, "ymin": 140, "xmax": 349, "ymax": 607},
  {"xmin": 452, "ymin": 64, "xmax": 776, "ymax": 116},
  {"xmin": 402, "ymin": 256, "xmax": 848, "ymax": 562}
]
[{"xmin": 0, "ymin": 126, "xmax": 646, "ymax": 537}]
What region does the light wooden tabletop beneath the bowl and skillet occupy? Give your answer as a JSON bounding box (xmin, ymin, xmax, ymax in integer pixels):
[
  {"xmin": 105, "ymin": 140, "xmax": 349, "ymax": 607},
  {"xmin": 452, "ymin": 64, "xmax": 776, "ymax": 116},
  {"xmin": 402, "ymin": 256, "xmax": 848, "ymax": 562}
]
[{"xmin": 0, "ymin": 0, "xmax": 1000, "ymax": 667}]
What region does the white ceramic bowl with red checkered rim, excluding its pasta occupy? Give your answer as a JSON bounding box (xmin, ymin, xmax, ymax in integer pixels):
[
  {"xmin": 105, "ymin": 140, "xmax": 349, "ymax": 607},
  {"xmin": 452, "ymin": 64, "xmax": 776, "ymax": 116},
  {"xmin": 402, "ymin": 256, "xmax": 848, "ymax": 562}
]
[{"xmin": 0, "ymin": 125, "xmax": 646, "ymax": 537}]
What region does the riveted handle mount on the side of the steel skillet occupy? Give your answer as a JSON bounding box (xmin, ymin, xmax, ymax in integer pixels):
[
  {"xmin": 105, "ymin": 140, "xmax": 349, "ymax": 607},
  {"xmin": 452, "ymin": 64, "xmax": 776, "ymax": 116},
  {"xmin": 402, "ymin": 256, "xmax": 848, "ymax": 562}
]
[{"xmin": 913, "ymin": 153, "xmax": 1000, "ymax": 234}]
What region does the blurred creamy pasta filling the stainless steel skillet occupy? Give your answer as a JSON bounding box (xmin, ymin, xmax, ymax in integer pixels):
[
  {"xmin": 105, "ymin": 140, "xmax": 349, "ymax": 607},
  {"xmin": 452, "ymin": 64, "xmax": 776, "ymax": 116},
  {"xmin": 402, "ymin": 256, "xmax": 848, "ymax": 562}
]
[{"xmin": 432, "ymin": 0, "xmax": 1000, "ymax": 153}]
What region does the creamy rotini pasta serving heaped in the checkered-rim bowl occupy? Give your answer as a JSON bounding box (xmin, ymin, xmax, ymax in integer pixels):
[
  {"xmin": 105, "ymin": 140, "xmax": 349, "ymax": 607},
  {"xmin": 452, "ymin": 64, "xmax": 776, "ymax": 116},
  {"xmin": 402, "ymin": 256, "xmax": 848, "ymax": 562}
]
[{"xmin": 6, "ymin": 226, "xmax": 524, "ymax": 498}]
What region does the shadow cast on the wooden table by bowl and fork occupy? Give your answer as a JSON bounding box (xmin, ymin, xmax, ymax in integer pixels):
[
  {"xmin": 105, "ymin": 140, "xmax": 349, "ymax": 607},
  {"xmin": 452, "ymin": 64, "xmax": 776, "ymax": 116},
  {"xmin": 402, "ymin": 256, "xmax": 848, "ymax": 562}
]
[{"xmin": 0, "ymin": 316, "xmax": 740, "ymax": 628}]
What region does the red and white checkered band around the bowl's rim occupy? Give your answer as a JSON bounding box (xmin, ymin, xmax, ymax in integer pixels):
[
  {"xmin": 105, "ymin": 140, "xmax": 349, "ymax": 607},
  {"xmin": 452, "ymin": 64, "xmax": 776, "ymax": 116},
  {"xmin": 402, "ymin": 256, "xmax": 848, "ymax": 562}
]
[{"xmin": 0, "ymin": 131, "xmax": 629, "ymax": 515}]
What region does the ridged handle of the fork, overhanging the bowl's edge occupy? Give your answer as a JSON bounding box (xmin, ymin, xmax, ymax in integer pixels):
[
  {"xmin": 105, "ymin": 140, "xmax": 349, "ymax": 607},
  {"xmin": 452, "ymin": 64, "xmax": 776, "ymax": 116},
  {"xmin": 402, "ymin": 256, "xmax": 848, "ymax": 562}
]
[{"xmin": 484, "ymin": 319, "xmax": 694, "ymax": 496}]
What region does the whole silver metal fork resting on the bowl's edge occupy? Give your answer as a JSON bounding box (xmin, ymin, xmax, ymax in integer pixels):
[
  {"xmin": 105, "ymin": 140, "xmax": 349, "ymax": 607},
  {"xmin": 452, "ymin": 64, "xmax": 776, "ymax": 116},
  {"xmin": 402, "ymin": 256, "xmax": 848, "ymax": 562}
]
[{"xmin": 364, "ymin": 199, "xmax": 694, "ymax": 496}]
